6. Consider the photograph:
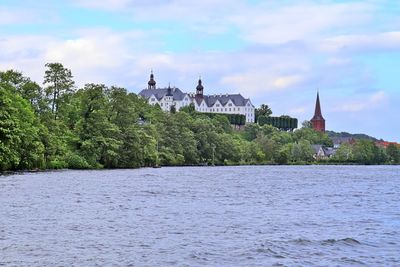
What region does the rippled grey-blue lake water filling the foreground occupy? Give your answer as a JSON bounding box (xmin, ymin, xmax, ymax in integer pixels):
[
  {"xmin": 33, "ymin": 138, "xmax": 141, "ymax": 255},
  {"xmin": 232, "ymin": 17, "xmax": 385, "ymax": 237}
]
[{"xmin": 0, "ymin": 166, "xmax": 400, "ymax": 266}]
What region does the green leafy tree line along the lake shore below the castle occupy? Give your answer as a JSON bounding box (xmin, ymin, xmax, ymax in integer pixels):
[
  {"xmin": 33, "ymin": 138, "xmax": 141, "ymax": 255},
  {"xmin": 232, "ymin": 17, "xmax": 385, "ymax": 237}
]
[{"xmin": 0, "ymin": 63, "xmax": 400, "ymax": 171}]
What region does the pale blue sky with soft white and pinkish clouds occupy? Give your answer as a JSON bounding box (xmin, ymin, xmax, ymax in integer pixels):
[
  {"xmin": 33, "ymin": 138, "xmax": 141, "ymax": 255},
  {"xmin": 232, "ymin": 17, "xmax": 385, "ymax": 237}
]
[{"xmin": 0, "ymin": 0, "xmax": 400, "ymax": 142}]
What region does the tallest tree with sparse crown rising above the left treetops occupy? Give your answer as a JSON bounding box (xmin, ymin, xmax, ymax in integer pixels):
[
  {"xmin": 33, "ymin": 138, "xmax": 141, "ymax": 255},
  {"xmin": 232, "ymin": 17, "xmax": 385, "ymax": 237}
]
[{"xmin": 43, "ymin": 63, "xmax": 75, "ymax": 120}]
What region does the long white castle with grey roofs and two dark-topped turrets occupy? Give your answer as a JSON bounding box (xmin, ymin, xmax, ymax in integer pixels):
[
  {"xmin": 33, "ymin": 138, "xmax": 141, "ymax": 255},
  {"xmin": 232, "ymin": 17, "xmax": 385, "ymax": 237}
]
[{"xmin": 139, "ymin": 72, "xmax": 255, "ymax": 123}]
